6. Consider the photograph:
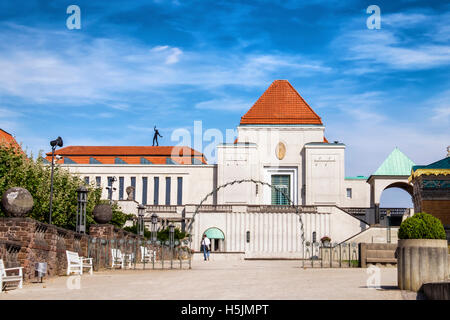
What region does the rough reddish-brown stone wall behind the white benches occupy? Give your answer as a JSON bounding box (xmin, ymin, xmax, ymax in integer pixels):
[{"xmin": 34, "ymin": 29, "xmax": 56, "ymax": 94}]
[{"xmin": 0, "ymin": 218, "xmax": 142, "ymax": 281}]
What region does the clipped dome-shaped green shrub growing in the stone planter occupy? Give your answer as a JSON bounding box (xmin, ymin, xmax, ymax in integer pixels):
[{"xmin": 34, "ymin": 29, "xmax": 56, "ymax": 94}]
[{"xmin": 398, "ymin": 213, "xmax": 446, "ymax": 239}]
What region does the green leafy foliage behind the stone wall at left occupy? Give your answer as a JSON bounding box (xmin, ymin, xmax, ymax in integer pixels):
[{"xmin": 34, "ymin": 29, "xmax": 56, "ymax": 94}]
[{"xmin": 0, "ymin": 144, "xmax": 127, "ymax": 230}]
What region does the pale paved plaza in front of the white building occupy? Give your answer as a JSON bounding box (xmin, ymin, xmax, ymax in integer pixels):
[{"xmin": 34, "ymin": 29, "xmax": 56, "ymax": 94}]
[{"xmin": 0, "ymin": 260, "xmax": 422, "ymax": 300}]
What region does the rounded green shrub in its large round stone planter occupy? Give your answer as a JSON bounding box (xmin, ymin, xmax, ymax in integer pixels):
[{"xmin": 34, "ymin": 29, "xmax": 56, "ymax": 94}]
[{"xmin": 395, "ymin": 213, "xmax": 449, "ymax": 292}]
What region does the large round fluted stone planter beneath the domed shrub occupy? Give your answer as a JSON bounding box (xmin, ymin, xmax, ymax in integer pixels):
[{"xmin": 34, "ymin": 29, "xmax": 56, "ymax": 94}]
[{"xmin": 396, "ymin": 239, "xmax": 449, "ymax": 292}]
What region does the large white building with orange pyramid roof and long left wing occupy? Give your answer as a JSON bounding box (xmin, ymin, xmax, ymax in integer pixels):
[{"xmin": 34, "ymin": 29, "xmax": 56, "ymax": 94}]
[{"xmin": 47, "ymin": 80, "xmax": 412, "ymax": 258}]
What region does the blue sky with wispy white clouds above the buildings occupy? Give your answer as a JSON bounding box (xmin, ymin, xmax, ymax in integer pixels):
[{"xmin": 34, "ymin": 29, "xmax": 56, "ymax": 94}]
[{"xmin": 0, "ymin": 0, "xmax": 450, "ymax": 208}]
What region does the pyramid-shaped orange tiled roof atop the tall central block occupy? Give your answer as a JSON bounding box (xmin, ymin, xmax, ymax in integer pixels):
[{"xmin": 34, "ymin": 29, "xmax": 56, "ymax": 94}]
[{"xmin": 241, "ymin": 80, "xmax": 322, "ymax": 125}]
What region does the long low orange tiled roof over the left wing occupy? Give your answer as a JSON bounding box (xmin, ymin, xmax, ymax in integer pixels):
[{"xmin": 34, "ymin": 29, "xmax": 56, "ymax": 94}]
[{"xmin": 46, "ymin": 146, "xmax": 207, "ymax": 164}]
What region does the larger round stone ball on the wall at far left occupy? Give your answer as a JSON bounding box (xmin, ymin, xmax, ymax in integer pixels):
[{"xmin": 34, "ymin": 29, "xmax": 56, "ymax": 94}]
[{"xmin": 2, "ymin": 187, "xmax": 34, "ymax": 217}]
